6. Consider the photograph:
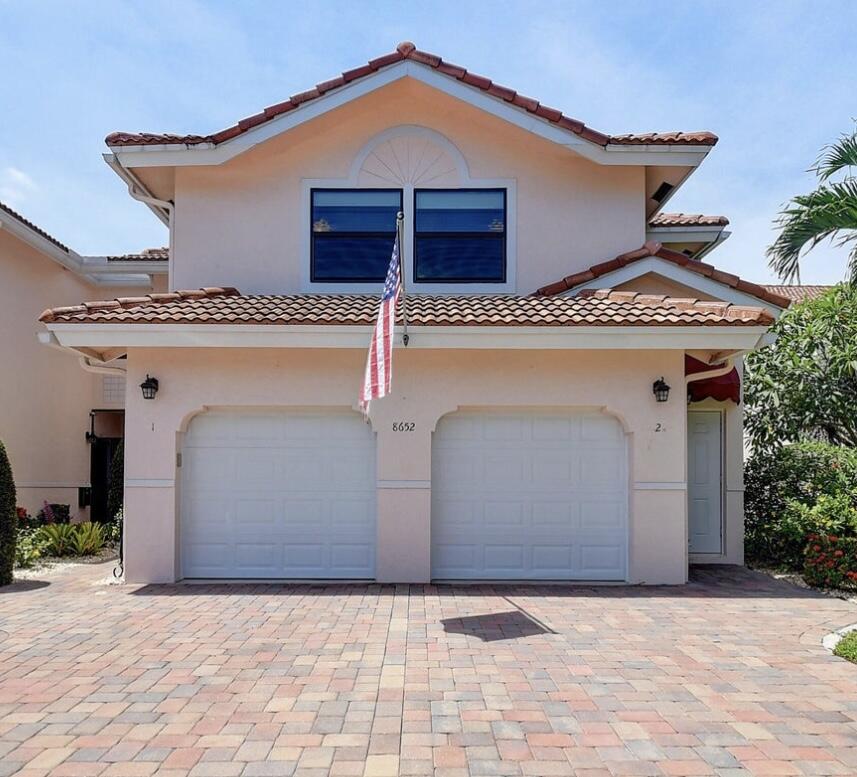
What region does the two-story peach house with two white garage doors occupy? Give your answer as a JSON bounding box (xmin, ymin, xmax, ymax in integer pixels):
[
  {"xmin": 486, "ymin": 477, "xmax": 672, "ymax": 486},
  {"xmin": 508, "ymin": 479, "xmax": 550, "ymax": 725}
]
[{"xmin": 42, "ymin": 43, "xmax": 789, "ymax": 583}]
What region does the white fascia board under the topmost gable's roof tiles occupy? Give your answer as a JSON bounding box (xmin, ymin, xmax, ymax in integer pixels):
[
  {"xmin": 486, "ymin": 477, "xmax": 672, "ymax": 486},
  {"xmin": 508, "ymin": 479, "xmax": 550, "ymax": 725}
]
[{"xmin": 105, "ymin": 60, "xmax": 712, "ymax": 172}]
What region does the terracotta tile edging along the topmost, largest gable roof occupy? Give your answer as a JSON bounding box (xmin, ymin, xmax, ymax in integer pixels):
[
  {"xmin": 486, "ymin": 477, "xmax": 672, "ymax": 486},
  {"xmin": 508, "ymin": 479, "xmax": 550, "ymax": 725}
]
[{"xmin": 105, "ymin": 42, "xmax": 717, "ymax": 152}]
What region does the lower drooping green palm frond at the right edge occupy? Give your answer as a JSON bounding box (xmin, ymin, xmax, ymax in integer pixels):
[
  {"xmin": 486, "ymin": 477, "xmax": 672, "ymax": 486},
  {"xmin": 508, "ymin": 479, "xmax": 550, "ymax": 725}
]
[{"xmin": 767, "ymin": 178, "xmax": 857, "ymax": 283}]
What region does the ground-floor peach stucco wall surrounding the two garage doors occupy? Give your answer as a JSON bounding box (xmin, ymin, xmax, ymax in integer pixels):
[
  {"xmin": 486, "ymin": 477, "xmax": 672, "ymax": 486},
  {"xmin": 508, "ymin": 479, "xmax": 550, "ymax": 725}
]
[{"xmin": 125, "ymin": 348, "xmax": 687, "ymax": 583}]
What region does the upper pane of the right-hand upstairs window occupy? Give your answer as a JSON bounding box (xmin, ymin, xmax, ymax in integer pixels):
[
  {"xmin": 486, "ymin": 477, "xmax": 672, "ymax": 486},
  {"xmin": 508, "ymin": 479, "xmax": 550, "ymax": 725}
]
[{"xmin": 416, "ymin": 189, "xmax": 506, "ymax": 232}]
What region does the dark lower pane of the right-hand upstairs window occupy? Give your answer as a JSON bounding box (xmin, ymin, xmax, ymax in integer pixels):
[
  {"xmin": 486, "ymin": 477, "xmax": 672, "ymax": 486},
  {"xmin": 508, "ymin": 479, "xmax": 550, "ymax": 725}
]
[{"xmin": 416, "ymin": 235, "xmax": 506, "ymax": 283}]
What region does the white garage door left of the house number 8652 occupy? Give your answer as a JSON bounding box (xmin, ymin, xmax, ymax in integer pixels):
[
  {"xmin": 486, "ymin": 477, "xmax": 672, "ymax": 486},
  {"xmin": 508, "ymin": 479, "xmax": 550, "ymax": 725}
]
[{"xmin": 181, "ymin": 411, "xmax": 376, "ymax": 578}]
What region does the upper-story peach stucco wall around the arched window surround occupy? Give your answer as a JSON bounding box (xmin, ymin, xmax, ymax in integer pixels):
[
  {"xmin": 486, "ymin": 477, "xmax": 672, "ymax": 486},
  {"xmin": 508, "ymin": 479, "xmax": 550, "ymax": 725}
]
[{"xmin": 173, "ymin": 79, "xmax": 645, "ymax": 293}]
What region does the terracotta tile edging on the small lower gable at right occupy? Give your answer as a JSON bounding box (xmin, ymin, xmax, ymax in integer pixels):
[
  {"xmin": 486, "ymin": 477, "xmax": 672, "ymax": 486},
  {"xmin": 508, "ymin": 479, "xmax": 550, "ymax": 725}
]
[{"xmin": 536, "ymin": 240, "xmax": 791, "ymax": 308}]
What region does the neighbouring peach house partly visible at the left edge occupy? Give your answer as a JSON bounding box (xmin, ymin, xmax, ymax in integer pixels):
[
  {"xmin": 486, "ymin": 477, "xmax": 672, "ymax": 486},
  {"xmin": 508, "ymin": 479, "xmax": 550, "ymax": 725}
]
[{"xmin": 0, "ymin": 203, "xmax": 167, "ymax": 520}]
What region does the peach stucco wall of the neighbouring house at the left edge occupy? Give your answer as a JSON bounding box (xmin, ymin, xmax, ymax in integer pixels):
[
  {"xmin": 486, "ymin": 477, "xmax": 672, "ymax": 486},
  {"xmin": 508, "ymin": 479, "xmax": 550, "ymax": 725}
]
[{"xmin": 0, "ymin": 229, "xmax": 163, "ymax": 518}]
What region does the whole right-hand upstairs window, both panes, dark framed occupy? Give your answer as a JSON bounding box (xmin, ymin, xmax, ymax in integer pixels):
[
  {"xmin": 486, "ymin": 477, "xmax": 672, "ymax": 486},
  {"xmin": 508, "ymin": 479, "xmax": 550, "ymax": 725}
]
[{"xmin": 413, "ymin": 189, "xmax": 506, "ymax": 283}]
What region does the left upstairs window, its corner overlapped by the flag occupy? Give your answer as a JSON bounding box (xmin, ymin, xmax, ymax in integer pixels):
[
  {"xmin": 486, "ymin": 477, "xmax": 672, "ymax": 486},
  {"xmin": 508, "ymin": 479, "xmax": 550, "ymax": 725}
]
[{"xmin": 310, "ymin": 189, "xmax": 402, "ymax": 283}]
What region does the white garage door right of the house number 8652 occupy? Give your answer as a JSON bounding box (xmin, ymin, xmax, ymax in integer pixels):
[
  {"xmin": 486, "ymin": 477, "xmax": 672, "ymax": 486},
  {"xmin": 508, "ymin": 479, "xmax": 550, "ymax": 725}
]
[{"xmin": 432, "ymin": 412, "xmax": 628, "ymax": 580}]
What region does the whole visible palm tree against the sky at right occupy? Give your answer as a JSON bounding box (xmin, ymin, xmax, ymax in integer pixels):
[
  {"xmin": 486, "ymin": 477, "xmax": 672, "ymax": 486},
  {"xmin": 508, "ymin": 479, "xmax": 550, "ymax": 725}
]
[{"xmin": 767, "ymin": 129, "xmax": 857, "ymax": 283}]
